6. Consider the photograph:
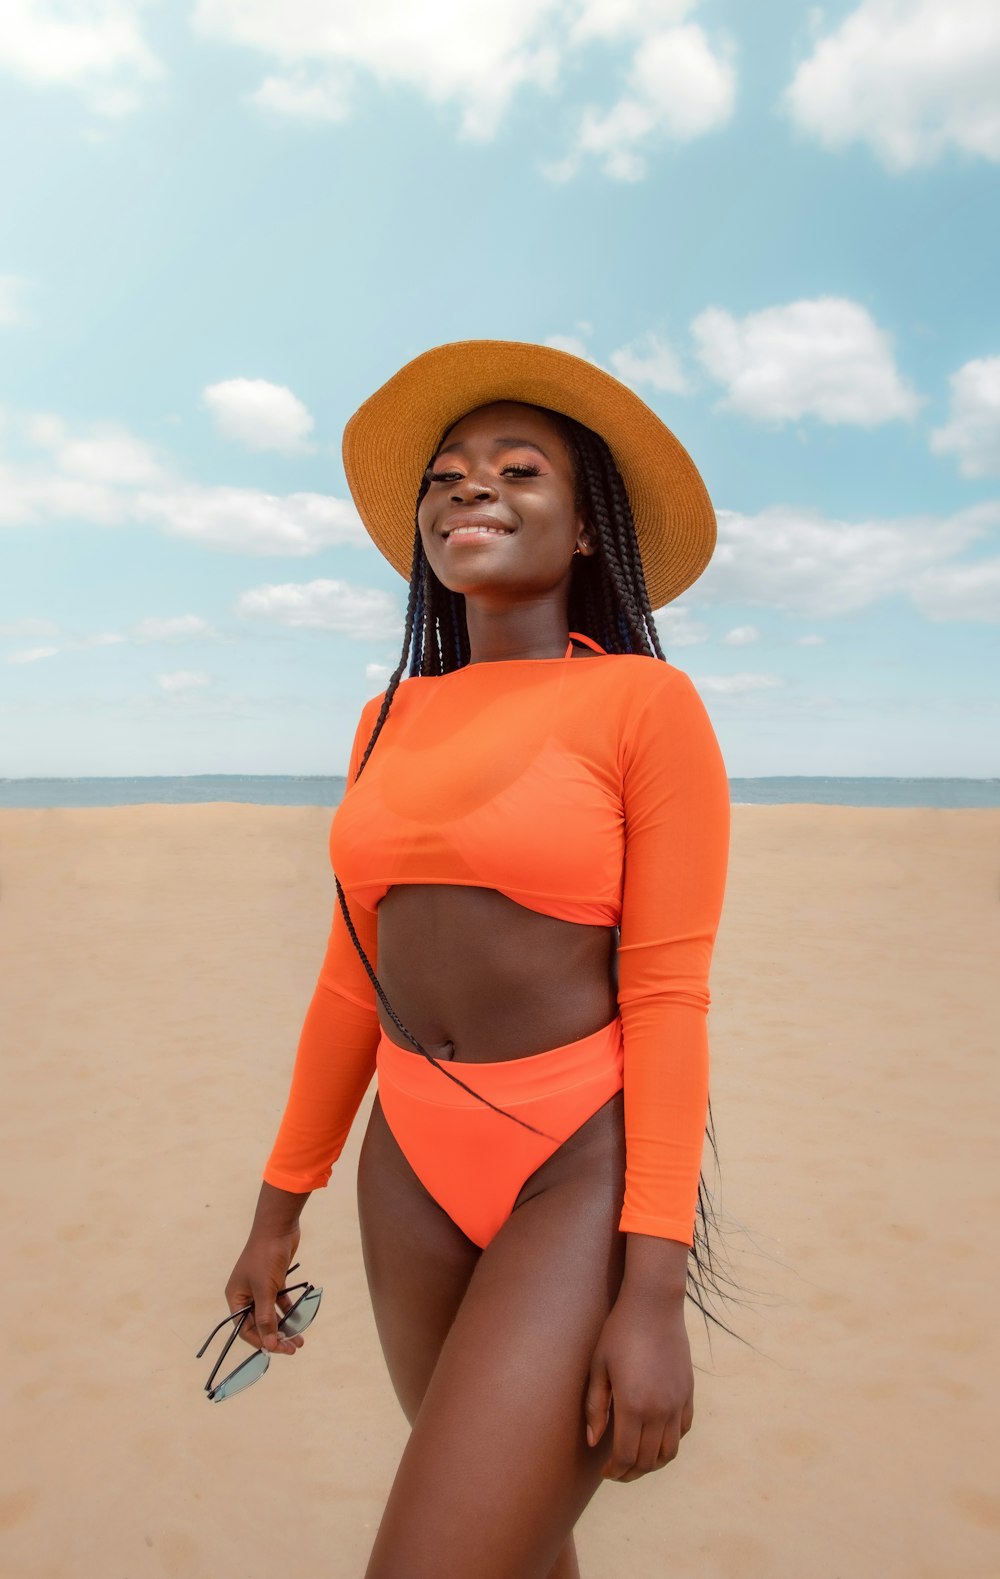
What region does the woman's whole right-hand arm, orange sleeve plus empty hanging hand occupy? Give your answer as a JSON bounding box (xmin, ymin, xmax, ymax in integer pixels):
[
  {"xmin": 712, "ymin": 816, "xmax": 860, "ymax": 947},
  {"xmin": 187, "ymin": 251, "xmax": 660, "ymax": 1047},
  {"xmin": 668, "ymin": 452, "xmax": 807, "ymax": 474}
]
[{"xmin": 586, "ymin": 668, "xmax": 730, "ymax": 1480}]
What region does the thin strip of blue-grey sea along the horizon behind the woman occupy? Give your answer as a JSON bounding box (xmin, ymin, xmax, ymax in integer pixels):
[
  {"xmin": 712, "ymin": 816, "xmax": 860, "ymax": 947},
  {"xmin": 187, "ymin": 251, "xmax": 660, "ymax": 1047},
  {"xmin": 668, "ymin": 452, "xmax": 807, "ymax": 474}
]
[{"xmin": 0, "ymin": 774, "xmax": 1000, "ymax": 807}]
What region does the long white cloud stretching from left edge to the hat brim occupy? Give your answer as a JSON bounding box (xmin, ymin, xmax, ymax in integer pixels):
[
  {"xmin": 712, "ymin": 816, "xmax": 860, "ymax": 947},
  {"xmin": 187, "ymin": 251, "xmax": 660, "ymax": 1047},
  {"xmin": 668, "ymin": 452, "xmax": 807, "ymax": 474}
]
[{"xmin": 0, "ymin": 414, "xmax": 371, "ymax": 556}]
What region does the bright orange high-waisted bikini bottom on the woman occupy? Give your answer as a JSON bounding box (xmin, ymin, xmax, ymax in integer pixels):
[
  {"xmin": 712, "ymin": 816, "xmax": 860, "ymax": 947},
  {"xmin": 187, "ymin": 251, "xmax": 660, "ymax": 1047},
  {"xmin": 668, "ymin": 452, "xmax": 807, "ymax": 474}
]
[{"xmin": 376, "ymin": 1017, "xmax": 622, "ymax": 1249}]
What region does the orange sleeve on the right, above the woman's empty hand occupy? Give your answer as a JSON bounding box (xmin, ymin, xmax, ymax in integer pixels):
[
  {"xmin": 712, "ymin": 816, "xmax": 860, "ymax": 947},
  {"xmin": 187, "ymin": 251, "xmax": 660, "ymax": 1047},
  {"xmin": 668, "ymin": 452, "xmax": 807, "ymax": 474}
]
[{"xmin": 618, "ymin": 665, "xmax": 730, "ymax": 1244}]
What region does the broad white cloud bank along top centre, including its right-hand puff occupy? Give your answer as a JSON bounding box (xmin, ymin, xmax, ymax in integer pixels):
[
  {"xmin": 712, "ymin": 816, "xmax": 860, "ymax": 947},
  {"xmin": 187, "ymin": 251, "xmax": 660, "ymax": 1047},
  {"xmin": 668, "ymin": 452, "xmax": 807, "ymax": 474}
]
[{"xmin": 193, "ymin": 0, "xmax": 735, "ymax": 180}]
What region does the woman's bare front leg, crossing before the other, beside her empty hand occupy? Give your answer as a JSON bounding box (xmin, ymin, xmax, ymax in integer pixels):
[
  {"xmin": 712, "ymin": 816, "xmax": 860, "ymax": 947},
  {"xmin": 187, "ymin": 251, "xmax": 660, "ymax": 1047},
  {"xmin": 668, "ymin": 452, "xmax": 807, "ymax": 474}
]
[{"xmin": 358, "ymin": 1094, "xmax": 624, "ymax": 1579}]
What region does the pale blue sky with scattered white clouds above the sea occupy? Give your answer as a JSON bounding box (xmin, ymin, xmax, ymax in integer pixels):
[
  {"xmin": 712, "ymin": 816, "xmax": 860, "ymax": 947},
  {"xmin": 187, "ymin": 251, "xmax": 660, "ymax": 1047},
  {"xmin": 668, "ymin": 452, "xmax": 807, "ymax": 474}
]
[{"xmin": 0, "ymin": 0, "xmax": 1000, "ymax": 775}]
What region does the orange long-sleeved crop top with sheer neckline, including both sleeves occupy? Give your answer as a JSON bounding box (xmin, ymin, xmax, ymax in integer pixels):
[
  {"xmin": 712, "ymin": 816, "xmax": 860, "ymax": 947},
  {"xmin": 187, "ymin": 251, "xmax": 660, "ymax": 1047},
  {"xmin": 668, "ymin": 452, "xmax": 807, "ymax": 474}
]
[{"xmin": 264, "ymin": 633, "xmax": 730, "ymax": 1244}]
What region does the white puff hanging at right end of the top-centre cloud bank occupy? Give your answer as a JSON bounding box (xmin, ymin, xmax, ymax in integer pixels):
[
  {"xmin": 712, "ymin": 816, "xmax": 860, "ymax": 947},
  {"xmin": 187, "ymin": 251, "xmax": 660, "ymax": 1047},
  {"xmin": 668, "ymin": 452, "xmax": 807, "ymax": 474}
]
[{"xmin": 547, "ymin": 20, "xmax": 736, "ymax": 182}]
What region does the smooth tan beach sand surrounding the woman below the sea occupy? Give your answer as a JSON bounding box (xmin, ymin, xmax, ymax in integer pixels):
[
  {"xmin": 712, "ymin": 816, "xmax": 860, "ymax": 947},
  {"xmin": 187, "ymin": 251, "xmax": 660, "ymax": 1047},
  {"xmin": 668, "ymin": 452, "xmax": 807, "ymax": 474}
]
[{"xmin": 0, "ymin": 805, "xmax": 1000, "ymax": 1579}]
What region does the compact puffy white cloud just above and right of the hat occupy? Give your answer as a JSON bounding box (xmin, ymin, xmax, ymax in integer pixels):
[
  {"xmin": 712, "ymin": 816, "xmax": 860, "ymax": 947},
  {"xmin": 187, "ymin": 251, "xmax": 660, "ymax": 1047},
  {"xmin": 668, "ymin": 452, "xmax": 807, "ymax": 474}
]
[{"xmin": 690, "ymin": 297, "xmax": 919, "ymax": 428}]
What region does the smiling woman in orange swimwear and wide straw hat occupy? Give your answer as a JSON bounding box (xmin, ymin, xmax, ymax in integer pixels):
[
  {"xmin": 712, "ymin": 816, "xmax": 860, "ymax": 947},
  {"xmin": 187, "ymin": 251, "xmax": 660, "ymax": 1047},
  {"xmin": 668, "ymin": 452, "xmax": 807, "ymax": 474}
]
[{"xmin": 226, "ymin": 341, "xmax": 728, "ymax": 1579}]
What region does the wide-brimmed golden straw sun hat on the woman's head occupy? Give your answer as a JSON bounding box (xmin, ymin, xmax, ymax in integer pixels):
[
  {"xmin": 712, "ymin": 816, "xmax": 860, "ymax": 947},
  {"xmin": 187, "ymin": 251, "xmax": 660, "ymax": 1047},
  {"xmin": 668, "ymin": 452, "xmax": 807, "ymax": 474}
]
[{"xmin": 344, "ymin": 339, "xmax": 716, "ymax": 608}]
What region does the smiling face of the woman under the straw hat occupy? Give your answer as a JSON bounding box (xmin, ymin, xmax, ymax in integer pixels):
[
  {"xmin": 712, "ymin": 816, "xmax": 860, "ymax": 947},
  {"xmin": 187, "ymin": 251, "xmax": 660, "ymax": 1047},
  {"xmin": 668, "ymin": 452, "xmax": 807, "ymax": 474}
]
[{"xmin": 417, "ymin": 401, "xmax": 591, "ymax": 602}]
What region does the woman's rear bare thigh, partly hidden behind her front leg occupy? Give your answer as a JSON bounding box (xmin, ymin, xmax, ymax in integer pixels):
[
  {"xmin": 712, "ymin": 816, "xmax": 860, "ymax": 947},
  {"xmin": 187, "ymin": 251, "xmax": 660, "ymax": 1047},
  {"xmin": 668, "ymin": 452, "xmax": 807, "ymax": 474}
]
[{"xmin": 357, "ymin": 1097, "xmax": 480, "ymax": 1424}]
